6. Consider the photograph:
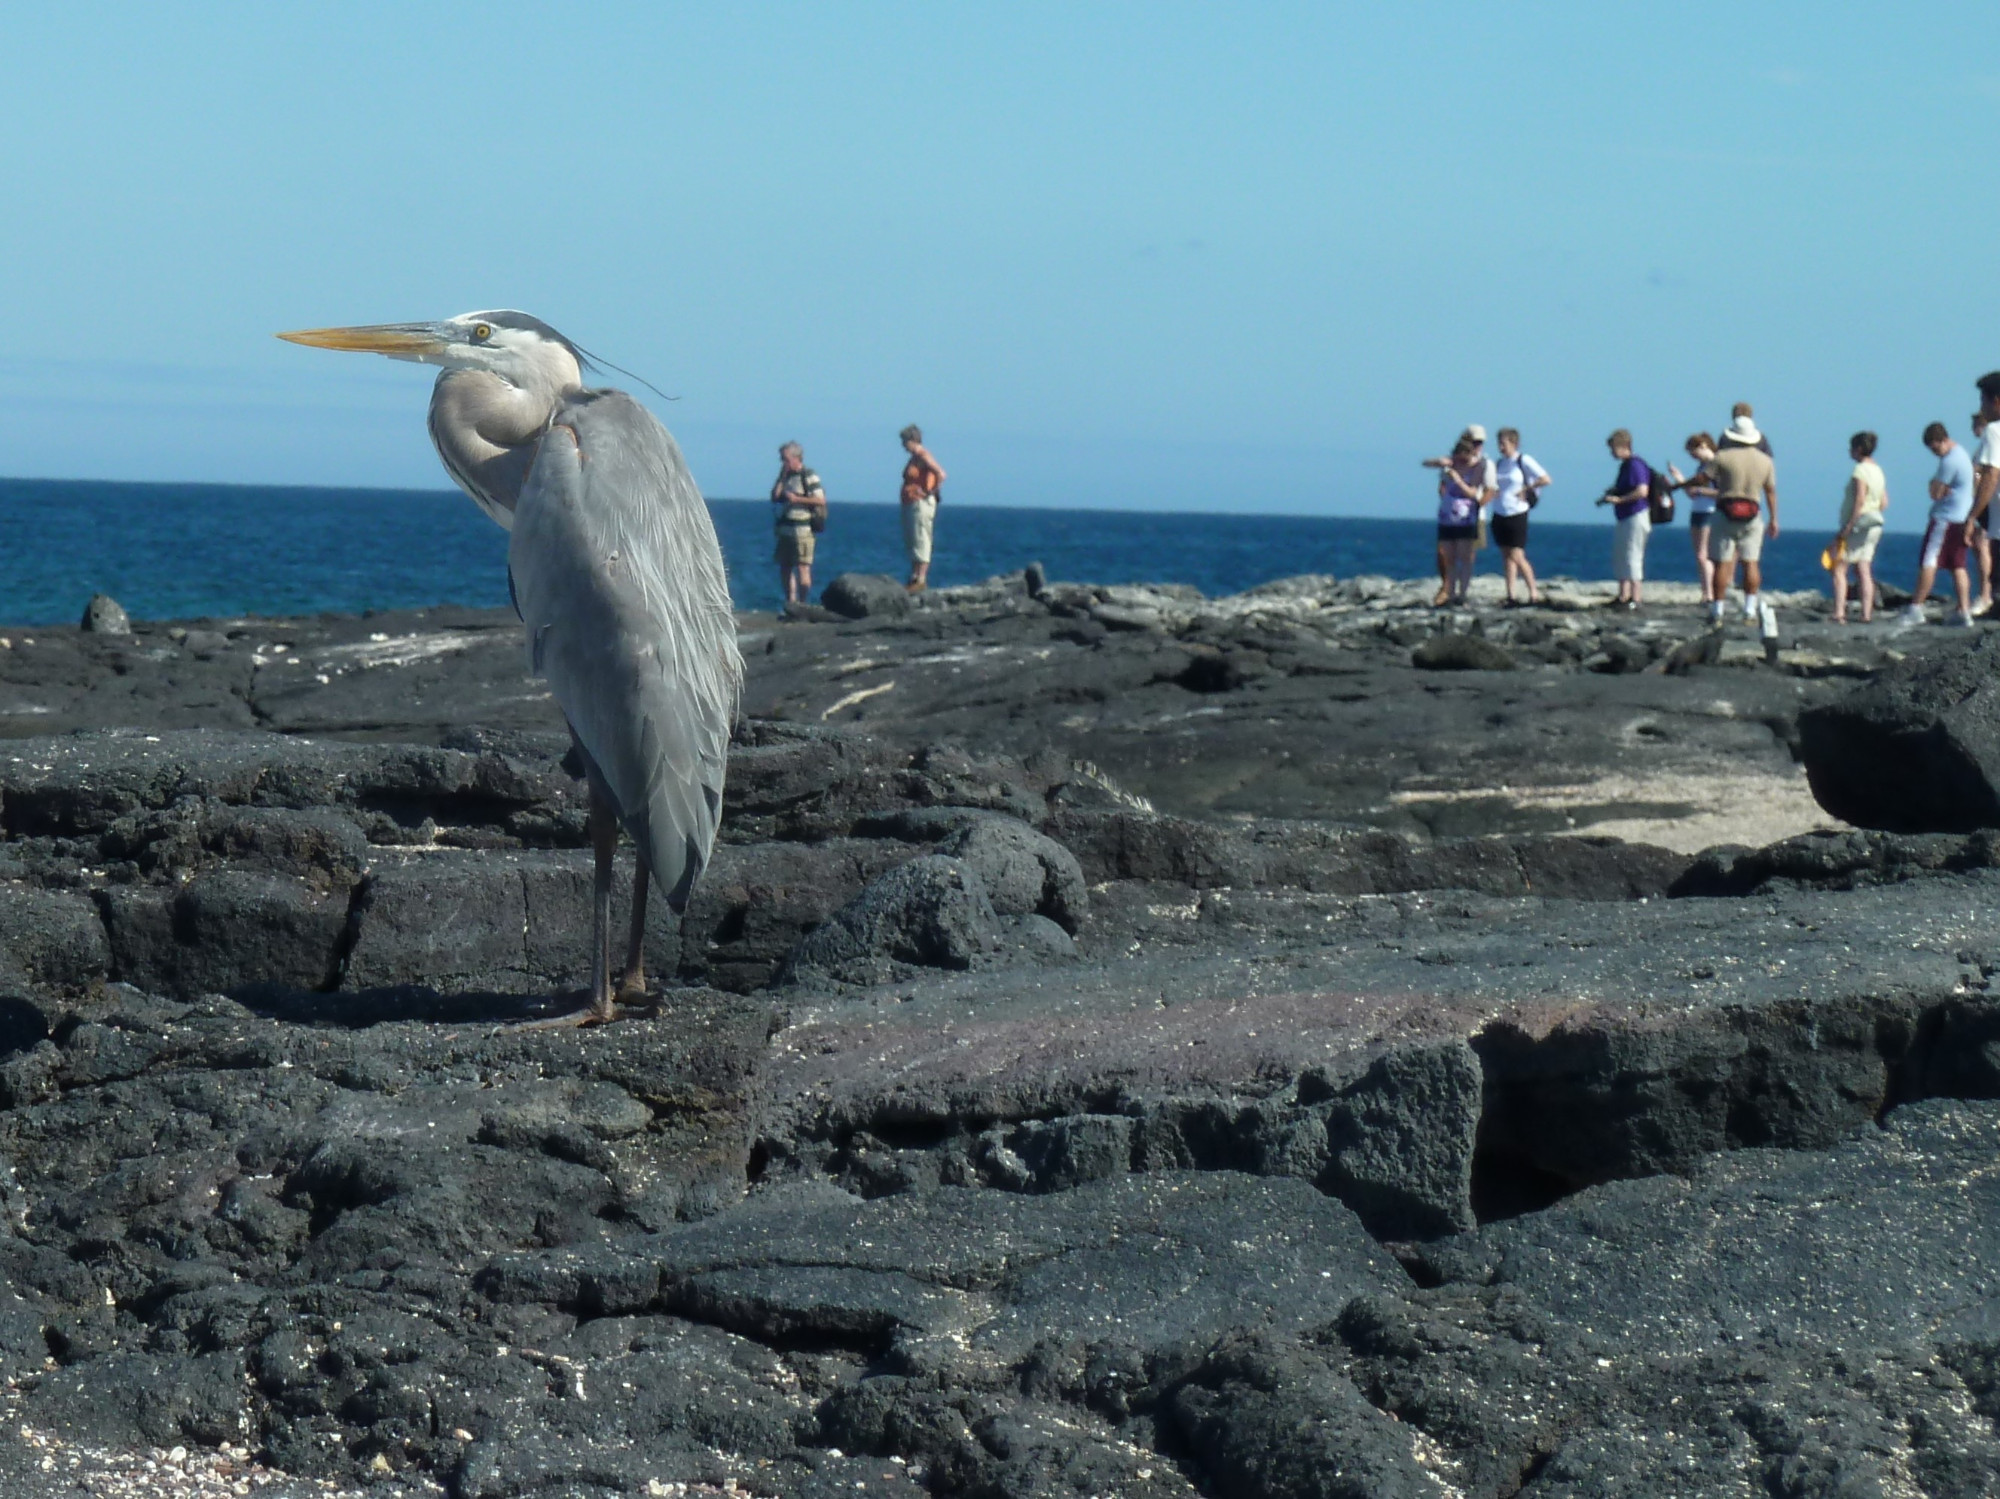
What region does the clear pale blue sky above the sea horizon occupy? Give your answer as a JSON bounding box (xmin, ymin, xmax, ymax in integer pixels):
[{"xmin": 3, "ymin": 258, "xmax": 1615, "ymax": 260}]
[{"xmin": 0, "ymin": 4, "xmax": 2000, "ymax": 528}]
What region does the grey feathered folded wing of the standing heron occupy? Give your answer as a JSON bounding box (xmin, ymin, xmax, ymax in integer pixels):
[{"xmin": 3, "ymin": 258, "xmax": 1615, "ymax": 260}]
[{"xmin": 508, "ymin": 390, "xmax": 742, "ymax": 909}]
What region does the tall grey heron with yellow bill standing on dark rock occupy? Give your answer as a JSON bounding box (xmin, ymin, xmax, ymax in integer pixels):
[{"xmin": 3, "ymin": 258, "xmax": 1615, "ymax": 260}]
[{"xmin": 278, "ymin": 312, "xmax": 742, "ymax": 1021}]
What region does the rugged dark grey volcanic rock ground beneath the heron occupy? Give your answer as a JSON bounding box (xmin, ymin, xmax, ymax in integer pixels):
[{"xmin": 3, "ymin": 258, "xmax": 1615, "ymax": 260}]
[{"xmin": 0, "ymin": 580, "xmax": 2000, "ymax": 1499}]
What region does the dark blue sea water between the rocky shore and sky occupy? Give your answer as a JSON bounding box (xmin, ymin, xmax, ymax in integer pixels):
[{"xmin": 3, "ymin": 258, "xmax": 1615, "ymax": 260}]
[{"xmin": 0, "ymin": 480, "xmax": 1918, "ymax": 624}]
